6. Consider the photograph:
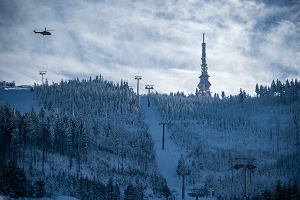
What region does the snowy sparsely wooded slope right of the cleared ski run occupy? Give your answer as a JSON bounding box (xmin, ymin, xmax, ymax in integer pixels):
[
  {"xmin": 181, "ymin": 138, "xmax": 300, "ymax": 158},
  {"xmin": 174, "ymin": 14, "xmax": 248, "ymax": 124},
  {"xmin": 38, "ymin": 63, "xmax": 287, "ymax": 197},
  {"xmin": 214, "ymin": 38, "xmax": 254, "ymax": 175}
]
[{"xmin": 155, "ymin": 94, "xmax": 300, "ymax": 198}]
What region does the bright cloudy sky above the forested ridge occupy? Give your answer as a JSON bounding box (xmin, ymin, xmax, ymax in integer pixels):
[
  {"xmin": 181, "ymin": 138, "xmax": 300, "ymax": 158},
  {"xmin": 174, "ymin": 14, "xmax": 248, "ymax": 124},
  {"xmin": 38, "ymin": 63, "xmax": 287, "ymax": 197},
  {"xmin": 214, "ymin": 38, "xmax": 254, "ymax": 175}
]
[{"xmin": 0, "ymin": 0, "xmax": 300, "ymax": 94}]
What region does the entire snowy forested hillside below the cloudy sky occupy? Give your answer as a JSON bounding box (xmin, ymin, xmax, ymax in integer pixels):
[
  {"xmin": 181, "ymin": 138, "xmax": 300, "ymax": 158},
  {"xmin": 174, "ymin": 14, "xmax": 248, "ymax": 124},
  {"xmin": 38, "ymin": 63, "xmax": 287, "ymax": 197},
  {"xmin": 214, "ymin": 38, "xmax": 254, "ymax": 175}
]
[{"xmin": 0, "ymin": 76, "xmax": 300, "ymax": 200}]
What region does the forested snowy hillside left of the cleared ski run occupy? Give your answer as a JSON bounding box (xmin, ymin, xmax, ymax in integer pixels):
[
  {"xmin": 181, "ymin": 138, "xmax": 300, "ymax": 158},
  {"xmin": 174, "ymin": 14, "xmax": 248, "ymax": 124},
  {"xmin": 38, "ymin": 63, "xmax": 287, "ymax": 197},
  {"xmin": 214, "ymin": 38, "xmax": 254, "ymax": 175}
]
[{"xmin": 0, "ymin": 76, "xmax": 164, "ymax": 199}]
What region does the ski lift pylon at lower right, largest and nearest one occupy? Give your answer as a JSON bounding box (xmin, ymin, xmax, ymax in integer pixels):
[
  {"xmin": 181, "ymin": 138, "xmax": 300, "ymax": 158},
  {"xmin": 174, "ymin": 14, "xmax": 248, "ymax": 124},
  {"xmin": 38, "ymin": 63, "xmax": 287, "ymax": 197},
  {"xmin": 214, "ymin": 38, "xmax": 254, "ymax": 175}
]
[{"xmin": 233, "ymin": 158, "xmax": 256, "ymax": 200}]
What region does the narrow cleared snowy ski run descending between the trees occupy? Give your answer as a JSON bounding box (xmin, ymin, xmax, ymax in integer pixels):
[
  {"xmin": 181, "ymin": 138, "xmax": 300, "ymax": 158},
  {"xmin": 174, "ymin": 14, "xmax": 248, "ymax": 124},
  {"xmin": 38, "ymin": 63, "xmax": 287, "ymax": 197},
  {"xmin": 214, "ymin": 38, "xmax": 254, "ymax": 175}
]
[{"xmin": 141, "ymin": 96, "xmax": 184, "ymax": 199}]
